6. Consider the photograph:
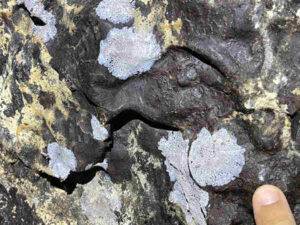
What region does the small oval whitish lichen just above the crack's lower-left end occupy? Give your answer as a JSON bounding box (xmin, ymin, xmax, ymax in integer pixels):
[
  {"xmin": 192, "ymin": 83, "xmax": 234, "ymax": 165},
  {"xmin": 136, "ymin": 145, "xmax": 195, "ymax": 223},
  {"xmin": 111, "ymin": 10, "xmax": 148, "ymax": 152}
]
[{"xmin": 47, "ymin": 142, "xmax": 77, "ymax": 180}]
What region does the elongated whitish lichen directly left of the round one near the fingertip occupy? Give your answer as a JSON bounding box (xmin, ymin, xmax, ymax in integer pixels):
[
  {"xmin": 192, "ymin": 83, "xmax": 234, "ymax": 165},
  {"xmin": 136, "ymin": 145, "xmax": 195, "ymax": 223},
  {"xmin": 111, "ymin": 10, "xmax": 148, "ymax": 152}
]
[{"xmin": 158, "ymin": 132, "xmax": 209, "ymax": 225}]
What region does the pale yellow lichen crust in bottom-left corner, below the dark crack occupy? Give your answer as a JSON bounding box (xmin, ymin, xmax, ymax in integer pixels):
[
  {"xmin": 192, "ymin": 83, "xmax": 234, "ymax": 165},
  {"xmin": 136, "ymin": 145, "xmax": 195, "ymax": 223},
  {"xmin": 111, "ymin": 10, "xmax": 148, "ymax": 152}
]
[{"xmin": 0, "ymin": 153, "xmax": 89, "ymax": 225}]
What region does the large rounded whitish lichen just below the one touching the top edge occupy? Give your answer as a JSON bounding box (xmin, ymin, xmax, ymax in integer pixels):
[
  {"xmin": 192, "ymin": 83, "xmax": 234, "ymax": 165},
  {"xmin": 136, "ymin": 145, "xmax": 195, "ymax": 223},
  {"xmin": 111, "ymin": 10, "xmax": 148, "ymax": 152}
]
[{"xmin": 98, "ymin": 27, "xmax": 161, "ymax": 80}]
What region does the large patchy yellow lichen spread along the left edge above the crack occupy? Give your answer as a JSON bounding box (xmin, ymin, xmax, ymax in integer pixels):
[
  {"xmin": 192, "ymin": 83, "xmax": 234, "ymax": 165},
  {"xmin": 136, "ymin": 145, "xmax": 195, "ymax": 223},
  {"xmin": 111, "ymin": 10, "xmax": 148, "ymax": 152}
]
[{"xmin": 0, "ymin": 9, "xmax": 79, "ymax": 174}]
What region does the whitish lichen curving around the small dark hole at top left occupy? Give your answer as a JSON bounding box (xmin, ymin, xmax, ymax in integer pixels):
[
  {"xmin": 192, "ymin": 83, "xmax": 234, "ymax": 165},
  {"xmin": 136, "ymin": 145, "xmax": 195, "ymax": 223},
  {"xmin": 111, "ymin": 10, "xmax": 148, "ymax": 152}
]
[{"xmin": 17, "ymin": 0, "xmax": 57, "ymax": 42}]
